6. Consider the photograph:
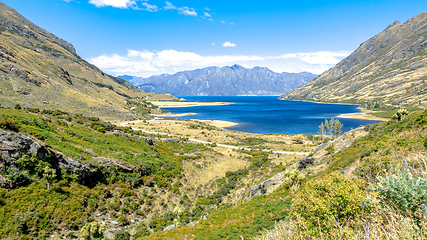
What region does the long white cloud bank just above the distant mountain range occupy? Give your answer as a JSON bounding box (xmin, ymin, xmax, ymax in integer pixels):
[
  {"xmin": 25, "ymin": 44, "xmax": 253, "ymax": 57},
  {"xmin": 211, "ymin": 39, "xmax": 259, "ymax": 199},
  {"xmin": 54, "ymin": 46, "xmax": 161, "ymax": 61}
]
[{"xmin": 90, "ymin": 50, "xmax": 350, "ymax": 77}]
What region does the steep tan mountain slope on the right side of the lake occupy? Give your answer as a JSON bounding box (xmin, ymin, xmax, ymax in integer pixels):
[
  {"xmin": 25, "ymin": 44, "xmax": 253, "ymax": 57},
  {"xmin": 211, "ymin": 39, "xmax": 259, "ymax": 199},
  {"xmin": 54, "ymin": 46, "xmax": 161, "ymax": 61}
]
[{"xmin": 281, "ymin": 12, "xmax": 427, "ymax": 107}]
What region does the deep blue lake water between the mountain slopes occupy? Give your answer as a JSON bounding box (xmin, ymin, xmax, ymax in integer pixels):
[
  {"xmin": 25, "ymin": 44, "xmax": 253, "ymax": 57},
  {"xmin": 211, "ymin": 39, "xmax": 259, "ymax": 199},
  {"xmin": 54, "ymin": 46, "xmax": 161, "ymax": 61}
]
[{"xmin": 158, "ymin": 96, "xmax": 379, "ymax": 134}]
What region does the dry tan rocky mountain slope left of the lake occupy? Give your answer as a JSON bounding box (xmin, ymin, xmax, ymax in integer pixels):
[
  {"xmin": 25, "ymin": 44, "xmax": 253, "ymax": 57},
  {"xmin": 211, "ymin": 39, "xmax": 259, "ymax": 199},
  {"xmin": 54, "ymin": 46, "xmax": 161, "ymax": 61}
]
[{"xmin": 0, "ymin": 2, "xmax": 176, "ymax": 120}]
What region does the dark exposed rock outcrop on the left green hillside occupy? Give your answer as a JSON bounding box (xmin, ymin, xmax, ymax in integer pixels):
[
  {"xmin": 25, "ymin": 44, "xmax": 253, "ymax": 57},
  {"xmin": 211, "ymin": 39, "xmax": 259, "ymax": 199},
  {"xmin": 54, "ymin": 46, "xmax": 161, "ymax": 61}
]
[{"xmin": 0, "ymin": 129, "xmax": 141, "ymax": 188}]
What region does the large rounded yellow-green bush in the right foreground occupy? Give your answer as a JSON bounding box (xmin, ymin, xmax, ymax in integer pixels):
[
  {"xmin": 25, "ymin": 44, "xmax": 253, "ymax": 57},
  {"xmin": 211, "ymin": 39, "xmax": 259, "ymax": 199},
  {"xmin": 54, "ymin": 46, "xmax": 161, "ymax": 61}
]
[{"xmin": 292, "ymin": 172, "xmax": 365, "ymax": 236}]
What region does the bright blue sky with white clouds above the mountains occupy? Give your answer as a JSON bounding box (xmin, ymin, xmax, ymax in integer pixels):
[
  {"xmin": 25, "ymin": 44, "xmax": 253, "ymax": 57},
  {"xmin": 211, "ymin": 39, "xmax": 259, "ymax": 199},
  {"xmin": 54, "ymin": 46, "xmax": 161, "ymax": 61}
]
[{"xmin": 2, "ymin": 0, "xmax": 427, "ymax": 77}]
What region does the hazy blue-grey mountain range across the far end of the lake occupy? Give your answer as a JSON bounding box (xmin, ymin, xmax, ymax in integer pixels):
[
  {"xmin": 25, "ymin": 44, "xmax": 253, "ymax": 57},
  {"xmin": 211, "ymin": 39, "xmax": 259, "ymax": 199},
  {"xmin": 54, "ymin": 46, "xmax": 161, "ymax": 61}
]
[{"xmin": 125, "ymin": 64, "xmax": 316, "ymax": 96}]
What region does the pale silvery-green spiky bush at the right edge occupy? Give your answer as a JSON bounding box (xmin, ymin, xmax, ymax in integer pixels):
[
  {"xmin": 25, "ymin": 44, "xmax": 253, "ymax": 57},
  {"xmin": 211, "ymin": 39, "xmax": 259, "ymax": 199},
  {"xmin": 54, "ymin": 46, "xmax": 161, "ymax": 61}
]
[{"xmin": 374, "ymin": 165, "xmax": 427, "ymax": 213}]
